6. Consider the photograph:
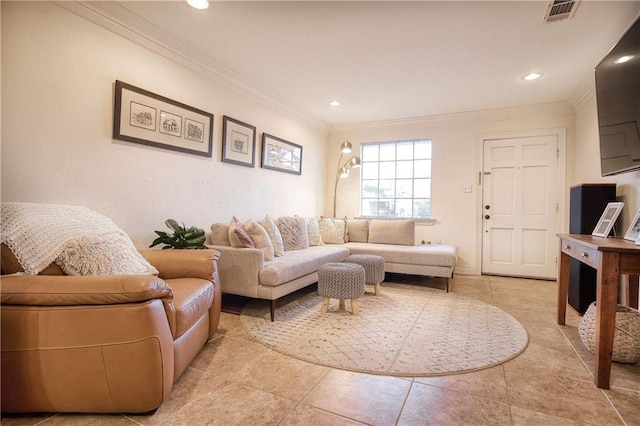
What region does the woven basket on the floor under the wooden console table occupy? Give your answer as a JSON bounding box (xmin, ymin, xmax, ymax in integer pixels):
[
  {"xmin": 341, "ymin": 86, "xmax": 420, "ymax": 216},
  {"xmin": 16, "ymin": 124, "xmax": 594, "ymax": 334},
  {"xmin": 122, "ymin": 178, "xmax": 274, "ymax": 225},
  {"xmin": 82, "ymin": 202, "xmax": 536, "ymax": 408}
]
[{"xmin": 578, "ymin": 302, "xmax": 640, "ymax": 364}]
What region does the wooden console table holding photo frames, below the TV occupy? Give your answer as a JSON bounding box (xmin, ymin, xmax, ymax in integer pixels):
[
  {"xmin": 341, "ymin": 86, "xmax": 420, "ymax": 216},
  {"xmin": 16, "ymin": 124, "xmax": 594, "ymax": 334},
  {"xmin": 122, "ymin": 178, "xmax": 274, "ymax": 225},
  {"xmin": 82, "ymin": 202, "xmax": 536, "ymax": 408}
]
[{"xmin": 557, "ymin": 234, "xmax": 640, "ymax": 389}]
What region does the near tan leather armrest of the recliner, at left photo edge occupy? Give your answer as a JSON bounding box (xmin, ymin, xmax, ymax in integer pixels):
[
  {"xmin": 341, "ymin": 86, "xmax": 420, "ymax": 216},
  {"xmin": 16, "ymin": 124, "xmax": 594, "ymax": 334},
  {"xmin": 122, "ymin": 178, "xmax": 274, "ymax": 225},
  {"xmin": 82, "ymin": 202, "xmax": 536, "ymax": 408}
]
[{"xmin": 0, "ymin": 275, "xmax": 173, "ymax": 306}]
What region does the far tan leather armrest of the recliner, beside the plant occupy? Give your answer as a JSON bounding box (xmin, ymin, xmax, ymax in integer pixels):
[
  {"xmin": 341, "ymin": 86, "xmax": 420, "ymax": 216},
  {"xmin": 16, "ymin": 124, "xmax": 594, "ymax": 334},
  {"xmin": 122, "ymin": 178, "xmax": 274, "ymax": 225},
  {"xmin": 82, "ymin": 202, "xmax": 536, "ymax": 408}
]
[{"xmin": 140, "ymin": 249, "xmax": 220, "ymax": 282}]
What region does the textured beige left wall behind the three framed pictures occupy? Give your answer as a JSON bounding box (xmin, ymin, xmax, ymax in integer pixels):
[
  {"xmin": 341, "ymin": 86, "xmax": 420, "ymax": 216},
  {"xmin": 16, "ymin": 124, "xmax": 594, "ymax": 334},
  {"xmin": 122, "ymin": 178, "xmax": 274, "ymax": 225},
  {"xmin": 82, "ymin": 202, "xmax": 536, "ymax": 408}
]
[{"xmin": 1, "ymin": 2, "xmax": 327, "ymax": 247}]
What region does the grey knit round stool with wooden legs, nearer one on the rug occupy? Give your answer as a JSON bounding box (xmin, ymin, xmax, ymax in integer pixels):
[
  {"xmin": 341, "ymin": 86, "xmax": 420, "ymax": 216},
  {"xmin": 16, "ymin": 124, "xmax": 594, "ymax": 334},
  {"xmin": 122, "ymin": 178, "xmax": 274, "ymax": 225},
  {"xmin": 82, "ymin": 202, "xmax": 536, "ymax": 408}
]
[{"xmin": 318, "ymin": 263, "xmax": 365, "ymax": 315}]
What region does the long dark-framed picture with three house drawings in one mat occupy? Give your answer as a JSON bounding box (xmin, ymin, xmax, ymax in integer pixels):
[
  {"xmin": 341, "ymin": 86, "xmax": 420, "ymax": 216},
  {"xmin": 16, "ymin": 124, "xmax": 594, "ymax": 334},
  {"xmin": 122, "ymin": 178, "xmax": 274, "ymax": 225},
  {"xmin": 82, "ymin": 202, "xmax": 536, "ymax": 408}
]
[{"xmin": 113, "ymin": 80, "xmax": 213, "ymax": 157}]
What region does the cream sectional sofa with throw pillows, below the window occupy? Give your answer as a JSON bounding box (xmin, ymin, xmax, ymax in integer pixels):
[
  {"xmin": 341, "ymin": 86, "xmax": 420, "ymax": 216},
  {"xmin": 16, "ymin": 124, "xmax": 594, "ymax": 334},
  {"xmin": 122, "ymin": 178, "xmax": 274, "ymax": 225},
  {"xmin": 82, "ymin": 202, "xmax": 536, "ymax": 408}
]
[{"xmin": 207, "ymin": 216, "xmax": 457, "ymax": 320}]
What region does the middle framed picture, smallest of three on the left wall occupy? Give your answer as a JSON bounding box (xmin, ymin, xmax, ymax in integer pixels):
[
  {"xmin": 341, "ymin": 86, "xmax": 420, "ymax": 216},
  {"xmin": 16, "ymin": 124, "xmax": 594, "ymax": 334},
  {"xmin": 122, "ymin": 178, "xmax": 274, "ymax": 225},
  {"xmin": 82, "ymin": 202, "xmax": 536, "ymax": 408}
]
[{"xmin": 222, "ymin": 115, "xmax": 256, "ymax": 167}]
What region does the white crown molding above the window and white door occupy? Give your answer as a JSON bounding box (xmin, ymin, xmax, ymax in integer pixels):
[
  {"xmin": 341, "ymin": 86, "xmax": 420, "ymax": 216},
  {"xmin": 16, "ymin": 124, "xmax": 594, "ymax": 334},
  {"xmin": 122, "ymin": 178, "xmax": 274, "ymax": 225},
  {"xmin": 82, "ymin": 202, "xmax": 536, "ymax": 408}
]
[{"xmin": 331, "ymin": 102, "xmax": 574, "ymax": 132}]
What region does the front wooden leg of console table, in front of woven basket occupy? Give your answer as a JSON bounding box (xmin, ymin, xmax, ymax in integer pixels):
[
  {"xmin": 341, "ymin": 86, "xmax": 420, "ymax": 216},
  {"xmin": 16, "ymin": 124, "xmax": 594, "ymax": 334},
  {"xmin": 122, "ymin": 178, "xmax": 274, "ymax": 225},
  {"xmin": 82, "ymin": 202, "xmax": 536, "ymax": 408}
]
[{"xmin": 595, "ymin": 252, "xmax": 620, "ymax": 389}]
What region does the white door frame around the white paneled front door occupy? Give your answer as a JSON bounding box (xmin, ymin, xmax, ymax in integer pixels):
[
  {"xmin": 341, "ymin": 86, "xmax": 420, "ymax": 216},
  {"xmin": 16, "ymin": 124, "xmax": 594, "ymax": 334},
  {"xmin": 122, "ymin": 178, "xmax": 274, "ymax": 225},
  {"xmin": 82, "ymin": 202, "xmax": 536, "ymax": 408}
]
[{"xmin": 475, "ymin": 127, "xmax": 569, "ymax": 278}]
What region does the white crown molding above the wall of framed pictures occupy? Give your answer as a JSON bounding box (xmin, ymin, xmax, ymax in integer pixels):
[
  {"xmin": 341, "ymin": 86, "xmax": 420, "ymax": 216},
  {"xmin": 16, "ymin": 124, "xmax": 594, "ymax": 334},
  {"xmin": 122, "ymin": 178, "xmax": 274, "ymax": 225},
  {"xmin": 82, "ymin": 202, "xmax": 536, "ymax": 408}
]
[{"xmin": 53, "ymin": 1, "xmax": 330, "ymax": 130}]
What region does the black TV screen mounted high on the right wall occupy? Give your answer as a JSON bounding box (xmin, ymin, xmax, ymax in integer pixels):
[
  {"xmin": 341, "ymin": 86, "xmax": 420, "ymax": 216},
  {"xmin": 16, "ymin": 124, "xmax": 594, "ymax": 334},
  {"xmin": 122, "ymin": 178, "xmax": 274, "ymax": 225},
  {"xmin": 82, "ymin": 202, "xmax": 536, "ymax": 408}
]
[{"xmin": 595, "ymin": 18, "xmax": 640, "ymax": 176}]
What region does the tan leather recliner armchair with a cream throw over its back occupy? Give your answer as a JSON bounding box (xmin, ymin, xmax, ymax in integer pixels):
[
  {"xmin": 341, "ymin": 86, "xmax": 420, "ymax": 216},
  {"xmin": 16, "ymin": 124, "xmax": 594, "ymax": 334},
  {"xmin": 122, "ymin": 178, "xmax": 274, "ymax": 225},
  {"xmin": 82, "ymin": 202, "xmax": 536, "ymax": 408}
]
[{"xmin": 0, "ymin": 245, "xmax": 221, "ymax": 413}]
